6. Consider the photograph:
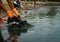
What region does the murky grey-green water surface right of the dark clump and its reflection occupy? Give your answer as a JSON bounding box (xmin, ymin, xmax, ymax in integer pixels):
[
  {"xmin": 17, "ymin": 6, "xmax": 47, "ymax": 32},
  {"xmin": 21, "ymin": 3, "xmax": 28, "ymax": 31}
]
[{"xmin": 1, "ymin": 6, "xmax": 60, "ymax": 42}]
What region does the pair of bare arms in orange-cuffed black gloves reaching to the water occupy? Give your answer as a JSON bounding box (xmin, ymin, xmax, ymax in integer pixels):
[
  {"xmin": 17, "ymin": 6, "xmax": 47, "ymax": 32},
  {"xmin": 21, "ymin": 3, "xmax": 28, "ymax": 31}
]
[{"xmin": 0, "ymin": 0, "xmax": 21, "ymax": 24}]
